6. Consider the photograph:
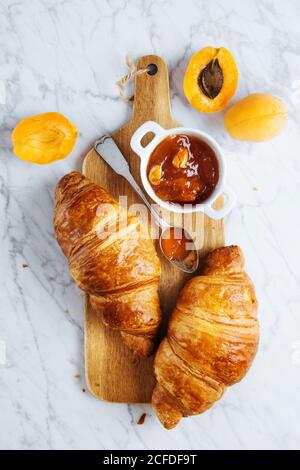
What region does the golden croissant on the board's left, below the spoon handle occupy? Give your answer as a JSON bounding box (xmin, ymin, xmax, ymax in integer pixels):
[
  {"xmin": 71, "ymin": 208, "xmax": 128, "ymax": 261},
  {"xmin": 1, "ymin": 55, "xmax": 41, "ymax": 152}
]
[{"xmin": 54, "ymin": 172, "xmax": 161, "ymax": 356}]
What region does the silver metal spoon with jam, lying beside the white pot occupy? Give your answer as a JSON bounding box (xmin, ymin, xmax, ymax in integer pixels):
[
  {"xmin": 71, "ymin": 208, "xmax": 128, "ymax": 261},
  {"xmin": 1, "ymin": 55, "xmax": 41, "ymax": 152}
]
[{"xmin": 94, "ymin": 135, "xmax": 199, "ymax": 273}]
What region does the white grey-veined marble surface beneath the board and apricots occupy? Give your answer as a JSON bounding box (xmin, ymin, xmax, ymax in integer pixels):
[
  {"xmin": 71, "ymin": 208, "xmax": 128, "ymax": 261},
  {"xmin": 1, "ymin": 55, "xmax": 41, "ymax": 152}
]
[{"xmin": 0, "ymin": 0, "xmax": 300, "ymax": 449}]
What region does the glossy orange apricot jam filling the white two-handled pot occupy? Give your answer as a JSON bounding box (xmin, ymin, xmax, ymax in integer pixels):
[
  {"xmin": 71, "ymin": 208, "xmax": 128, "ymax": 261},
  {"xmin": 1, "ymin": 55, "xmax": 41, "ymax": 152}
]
[{"xmin": 147, "ymin": 134, "xmax": 219, "ymax": 204}]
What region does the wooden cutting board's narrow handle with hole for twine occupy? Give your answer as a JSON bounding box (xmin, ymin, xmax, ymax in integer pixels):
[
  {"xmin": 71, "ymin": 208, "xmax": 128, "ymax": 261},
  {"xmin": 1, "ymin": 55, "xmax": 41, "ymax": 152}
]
[{"xmin": 131, "ymin": 55, "xmax": 173, "ymax": 127}]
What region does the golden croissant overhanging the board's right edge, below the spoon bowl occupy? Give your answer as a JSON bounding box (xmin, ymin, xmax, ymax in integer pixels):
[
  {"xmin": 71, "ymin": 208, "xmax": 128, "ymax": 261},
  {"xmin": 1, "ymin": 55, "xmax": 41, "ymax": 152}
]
[{"xmin": 152, "ymin": 246, "xmax": 259, "ymax": 429}]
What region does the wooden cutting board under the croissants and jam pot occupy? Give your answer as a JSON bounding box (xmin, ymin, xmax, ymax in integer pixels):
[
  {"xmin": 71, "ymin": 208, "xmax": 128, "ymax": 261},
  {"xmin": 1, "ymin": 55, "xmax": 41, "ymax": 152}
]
[{"xmin": 83, "ymin": 55, "xmax": 224, "ymax": 403}]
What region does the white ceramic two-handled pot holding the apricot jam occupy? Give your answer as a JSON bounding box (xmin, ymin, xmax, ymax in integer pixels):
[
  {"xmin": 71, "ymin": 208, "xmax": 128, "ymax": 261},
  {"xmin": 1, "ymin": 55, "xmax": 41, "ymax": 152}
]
[{"xmin": 130, "ymin": 121, "xmax": 236, "ymax": 220}]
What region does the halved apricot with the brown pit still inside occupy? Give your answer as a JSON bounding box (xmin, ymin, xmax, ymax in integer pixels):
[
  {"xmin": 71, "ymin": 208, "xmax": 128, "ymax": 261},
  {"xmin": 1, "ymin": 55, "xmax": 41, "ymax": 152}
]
[{"xmin": 183, "ymin": 46, "xmax": 238, "ymax": 113}]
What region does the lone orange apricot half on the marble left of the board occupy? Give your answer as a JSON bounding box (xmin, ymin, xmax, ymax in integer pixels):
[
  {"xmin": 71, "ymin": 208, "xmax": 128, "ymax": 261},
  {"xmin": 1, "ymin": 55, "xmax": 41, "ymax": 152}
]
[{"xmin": 12, "ymin": 113, "xmax": 78, "ymax": 164}]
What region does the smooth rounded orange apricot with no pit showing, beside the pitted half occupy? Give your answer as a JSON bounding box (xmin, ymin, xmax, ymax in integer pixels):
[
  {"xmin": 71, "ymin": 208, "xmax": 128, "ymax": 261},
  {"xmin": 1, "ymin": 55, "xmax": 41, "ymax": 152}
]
[{"xmin": 224, "ymin": 93, "xmax": 287, "ymax": 142}]
